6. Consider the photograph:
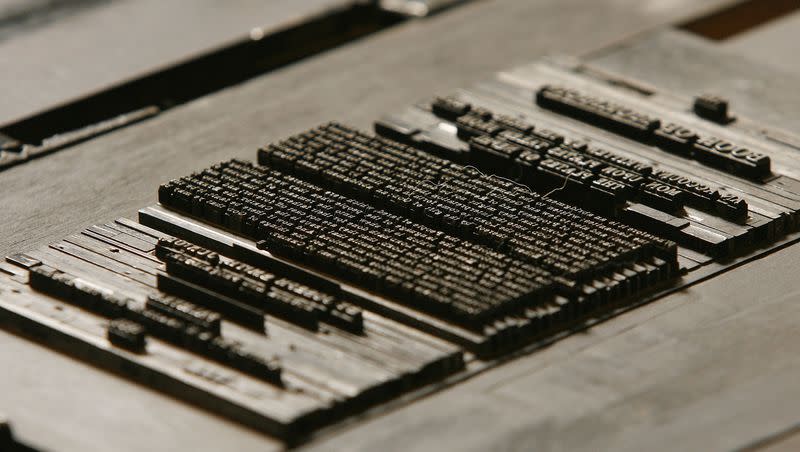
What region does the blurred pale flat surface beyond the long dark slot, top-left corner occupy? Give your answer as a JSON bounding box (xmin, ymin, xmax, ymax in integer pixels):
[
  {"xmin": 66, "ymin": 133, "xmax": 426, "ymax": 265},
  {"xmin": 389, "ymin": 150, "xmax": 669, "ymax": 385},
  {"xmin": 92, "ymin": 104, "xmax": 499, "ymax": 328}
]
[{"xmin": 0, "ymin": 0, "xmax": 355, "ymax": 125}]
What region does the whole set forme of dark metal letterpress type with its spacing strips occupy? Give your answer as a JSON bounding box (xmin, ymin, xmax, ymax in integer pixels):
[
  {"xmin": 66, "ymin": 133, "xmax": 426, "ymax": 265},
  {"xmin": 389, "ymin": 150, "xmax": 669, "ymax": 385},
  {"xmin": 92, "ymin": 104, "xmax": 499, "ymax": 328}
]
[{"xmin": 0, "ymin": 53, "xmax": 800, "ymax": 444}]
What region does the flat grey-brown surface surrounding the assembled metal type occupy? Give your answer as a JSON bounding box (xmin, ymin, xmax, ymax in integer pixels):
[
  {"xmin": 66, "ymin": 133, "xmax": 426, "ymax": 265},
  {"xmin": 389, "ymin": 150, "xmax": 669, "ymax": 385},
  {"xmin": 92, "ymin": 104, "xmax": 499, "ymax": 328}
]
[{"xmin": 0, "ymin": 0, "xmax": 776, "ymax": 451}]
